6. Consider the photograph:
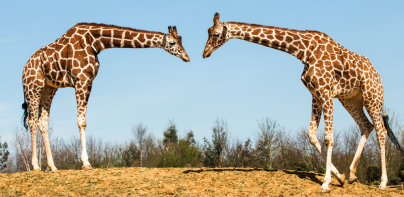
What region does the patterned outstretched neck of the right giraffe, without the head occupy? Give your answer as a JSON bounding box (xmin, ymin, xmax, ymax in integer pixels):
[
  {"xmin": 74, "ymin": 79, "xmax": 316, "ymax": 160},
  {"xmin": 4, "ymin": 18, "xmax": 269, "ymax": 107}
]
[{"xmin": 227, "ymin": 22, "xmax": 328, "ymax": 62}]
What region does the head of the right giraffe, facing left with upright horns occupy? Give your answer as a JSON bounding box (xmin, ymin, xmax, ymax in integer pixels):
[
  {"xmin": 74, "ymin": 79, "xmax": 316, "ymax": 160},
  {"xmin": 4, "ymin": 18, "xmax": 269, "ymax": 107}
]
[{"xmin": 203, "ymin": 13, "xmax": 230, "ymax": 58}]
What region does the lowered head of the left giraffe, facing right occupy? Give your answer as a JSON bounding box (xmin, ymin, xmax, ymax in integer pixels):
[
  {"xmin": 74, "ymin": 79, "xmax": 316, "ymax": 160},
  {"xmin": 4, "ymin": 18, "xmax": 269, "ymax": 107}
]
[{"xmin": 163, "ymin": 26, "xmax": 191, "ymax": 62}]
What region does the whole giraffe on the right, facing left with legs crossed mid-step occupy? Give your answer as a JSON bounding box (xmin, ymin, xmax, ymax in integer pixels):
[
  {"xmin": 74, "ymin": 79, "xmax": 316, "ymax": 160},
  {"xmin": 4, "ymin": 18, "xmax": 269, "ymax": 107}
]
[{"xmin": 203, "ymin": 13, "xmax": 403, "ymax": 193}]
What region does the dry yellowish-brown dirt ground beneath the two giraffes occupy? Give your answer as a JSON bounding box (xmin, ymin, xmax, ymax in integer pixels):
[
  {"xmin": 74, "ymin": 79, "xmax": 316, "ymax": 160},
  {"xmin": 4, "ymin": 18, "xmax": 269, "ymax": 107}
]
[{"xmin": 0, "ymin": 168, "xmax": 404, "ymax": 196}]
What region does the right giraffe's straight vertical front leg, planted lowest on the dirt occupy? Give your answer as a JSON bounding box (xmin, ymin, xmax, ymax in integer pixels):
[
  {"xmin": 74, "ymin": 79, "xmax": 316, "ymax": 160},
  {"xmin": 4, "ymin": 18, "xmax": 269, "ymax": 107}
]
[{"xmin": 320, "ymin": 92, "xmax": 334, "ymax": 193}]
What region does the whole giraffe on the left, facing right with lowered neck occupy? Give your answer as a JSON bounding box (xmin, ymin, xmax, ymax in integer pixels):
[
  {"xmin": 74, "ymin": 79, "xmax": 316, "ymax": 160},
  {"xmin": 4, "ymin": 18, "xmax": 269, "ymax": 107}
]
[{"xmin": 22, "ymin": 23, "xmax": 190, "ymax": 171}]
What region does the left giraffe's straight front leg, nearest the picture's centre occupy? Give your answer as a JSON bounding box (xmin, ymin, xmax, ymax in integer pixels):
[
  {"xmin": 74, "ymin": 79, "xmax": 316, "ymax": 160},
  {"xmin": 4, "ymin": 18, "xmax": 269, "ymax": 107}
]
[{"xmin": 75, "ymin": 81, "xmax": 92, "ymax": 170}]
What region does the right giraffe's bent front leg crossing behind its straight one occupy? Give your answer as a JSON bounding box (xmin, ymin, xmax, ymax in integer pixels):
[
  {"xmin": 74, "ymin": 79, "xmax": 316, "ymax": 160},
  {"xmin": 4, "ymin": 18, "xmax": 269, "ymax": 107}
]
[{"xmin": 308, "ymin": 96, "xmax": 345, "ymax": 185}]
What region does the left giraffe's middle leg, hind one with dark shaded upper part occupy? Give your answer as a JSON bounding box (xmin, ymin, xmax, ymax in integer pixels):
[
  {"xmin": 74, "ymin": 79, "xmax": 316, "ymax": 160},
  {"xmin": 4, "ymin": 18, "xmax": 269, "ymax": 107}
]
[{"xmin": 38, "ymin": 85, "xmax": 57, "ymax": 171}]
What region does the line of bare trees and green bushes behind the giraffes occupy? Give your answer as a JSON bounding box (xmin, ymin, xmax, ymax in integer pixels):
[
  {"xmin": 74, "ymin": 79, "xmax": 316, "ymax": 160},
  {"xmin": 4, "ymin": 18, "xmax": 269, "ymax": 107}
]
[{"xmin": 0, "ymin": 113, "xmax": 404, "ymax": 184}]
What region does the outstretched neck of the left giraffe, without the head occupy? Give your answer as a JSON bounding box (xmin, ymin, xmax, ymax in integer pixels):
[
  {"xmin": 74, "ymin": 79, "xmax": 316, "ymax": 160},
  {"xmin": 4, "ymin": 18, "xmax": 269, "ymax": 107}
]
[{"xmin": 70, "ymin": 24, "xmax": 165, "ymax": 53}]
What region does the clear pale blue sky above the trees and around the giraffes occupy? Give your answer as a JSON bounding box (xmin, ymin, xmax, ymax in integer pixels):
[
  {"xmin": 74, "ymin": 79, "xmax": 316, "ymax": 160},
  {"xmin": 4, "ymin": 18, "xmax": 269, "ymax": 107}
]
[{"xmin": 0, "ymin": 1, "xmax": 404, "ymax": 145}]
